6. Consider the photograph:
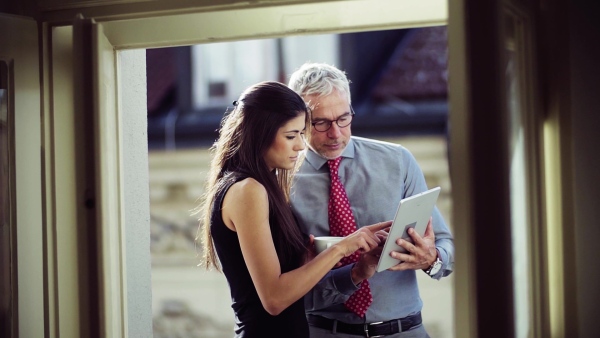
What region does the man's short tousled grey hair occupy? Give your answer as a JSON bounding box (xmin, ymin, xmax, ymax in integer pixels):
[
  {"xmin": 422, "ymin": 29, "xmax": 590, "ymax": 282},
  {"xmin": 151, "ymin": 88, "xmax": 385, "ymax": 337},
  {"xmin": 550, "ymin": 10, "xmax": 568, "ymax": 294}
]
[{"xmin": 288, "ymin": 63, "xmax": 351, "ymax": 103}]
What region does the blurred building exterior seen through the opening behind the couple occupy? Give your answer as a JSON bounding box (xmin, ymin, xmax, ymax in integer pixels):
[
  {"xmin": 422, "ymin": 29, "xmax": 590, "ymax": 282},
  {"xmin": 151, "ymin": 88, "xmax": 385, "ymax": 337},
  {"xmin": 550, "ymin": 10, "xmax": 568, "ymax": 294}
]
[{"xmin": 146, "ymin": 26, "xmax": 454, "ymax": 338}]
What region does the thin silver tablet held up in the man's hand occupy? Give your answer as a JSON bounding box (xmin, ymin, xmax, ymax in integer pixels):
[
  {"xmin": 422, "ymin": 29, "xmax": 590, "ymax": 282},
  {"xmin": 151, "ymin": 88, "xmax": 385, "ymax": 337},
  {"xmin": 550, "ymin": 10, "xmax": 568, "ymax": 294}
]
[{"xmin": 377, "ymin": 187, "xmax": 440, "ymax": 272}]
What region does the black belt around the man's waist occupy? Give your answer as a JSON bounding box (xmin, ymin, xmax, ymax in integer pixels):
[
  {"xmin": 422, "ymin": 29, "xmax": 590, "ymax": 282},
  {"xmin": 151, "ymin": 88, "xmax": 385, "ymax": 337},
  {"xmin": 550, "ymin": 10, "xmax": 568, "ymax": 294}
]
[{"xmin": 308, "ymin": 312, "xmax": 421, "ymax": 337}]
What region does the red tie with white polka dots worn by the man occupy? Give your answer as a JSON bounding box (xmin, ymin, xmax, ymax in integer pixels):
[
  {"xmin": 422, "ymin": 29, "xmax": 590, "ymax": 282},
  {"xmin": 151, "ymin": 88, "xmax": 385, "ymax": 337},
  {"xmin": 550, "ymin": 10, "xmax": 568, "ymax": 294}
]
[{"xmin": 327, "ymin": 157, "xmax": 373, "ymax": 317}]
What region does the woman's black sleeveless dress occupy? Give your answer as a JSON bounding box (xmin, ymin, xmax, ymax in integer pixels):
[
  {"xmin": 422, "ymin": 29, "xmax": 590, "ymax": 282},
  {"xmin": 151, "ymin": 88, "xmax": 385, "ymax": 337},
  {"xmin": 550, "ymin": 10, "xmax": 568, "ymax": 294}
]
[{"xmin": 210, "ymin": 176, "xmax": 309, "ymax": 338}]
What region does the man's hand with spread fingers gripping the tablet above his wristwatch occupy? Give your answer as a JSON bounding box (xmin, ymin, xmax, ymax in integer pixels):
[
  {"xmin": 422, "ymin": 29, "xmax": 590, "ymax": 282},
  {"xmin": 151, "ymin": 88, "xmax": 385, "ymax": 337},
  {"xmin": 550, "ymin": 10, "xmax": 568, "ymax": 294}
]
[{"xmin": 388, "ymin": 217, "xmax": 437, "ymax": 271}]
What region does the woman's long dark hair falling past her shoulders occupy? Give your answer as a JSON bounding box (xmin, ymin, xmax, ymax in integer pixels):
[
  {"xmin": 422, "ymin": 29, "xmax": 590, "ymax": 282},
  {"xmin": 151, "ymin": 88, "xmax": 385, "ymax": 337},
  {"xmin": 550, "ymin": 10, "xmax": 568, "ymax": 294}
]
[{"xmin": 200, "ymin": 81, "xmax": 309, "ymax": 270}]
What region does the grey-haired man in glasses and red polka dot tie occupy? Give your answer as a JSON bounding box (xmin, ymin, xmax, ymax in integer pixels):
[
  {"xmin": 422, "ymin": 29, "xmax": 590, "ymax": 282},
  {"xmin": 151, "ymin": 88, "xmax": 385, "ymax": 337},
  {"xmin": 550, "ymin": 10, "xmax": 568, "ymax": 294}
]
[{"xmin": 289, "ymin": 63, "xmax": 454, "ymax": 338}]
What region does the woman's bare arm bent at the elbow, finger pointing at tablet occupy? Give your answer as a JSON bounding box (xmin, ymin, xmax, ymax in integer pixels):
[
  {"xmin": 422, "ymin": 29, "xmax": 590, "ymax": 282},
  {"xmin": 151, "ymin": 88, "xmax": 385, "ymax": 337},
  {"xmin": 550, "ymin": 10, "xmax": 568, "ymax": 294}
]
[{"xmin": 222, "ymin": 178, "xmax": 390, "ymax": 315}]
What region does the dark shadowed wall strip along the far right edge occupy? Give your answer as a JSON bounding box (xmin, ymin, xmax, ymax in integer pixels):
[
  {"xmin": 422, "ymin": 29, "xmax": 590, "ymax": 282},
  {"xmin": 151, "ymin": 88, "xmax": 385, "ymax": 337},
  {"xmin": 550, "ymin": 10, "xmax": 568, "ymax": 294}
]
[{"xmin": 569, "ymin": 0, "xmax": 600, "ymax": 337}]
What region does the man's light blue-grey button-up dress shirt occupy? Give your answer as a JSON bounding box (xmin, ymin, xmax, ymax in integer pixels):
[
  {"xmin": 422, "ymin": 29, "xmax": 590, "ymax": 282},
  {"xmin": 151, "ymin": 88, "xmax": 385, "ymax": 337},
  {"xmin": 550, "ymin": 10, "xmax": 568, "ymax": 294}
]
[{"xmin": 291, "ymin": 136, "xmax": 454, "ymax": 324}]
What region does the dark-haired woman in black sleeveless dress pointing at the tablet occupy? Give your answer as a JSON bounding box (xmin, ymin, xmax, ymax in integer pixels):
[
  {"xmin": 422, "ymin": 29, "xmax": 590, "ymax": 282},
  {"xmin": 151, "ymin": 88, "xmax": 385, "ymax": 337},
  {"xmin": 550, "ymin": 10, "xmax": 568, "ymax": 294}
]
[{"xmin": 202, "ymin": 82, "xmax": 389, "ymax": 337}]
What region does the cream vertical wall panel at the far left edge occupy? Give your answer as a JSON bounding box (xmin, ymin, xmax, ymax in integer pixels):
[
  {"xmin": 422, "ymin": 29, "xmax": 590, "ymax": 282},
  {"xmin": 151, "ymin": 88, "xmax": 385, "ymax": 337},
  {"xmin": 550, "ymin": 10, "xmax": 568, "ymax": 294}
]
[{"xmin": 0, "ymin": 15, "xmax": 45, "ymax": 337}]
